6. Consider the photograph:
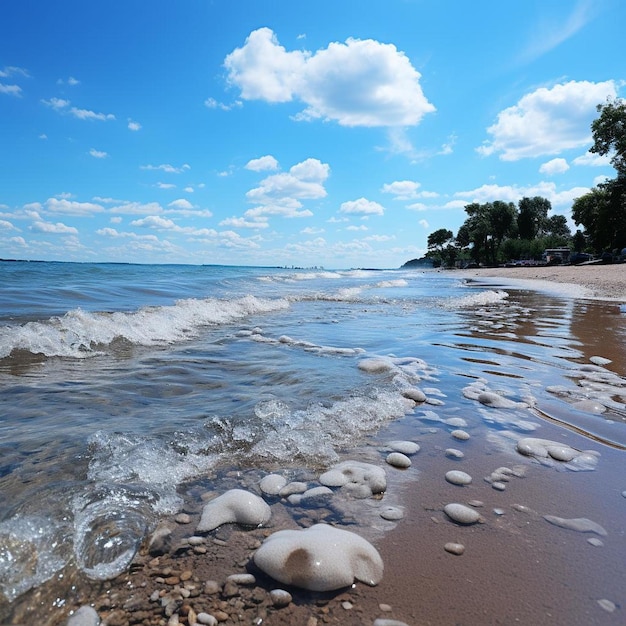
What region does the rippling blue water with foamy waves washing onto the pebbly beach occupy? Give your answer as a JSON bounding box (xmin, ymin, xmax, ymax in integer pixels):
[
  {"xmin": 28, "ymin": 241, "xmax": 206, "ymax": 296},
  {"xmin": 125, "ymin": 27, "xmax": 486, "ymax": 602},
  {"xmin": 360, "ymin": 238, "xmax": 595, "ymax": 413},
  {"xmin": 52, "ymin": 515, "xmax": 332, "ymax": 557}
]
[{"xmin": 0, "ymin": 262, "xmax": 626, "ymax": 621}]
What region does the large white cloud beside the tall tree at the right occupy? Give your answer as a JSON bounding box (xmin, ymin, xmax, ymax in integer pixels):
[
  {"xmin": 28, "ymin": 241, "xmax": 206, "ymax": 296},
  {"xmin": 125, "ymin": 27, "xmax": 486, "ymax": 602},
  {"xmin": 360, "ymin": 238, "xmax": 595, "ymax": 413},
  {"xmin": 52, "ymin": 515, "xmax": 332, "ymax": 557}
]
[{"xmin": 477, "ymin": 80, "xmax": 617, "ymax": 161}]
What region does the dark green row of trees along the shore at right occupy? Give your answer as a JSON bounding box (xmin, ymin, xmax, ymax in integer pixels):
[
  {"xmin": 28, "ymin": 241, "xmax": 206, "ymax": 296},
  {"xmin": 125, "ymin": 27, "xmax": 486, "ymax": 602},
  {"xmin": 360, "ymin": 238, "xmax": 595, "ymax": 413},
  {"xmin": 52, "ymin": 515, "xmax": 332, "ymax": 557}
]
[{"xmin": 426, "ymin": 99, "xmax": 626, "ymax": 266}]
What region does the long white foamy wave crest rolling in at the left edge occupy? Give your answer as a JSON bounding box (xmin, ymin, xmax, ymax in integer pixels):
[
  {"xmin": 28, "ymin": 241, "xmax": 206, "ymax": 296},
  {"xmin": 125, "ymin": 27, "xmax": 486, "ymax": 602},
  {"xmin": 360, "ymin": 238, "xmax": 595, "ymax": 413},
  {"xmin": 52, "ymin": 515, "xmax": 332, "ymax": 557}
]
[{"xmin": 0, "ymin": 296, "xmax": 290, "ymax": 358}]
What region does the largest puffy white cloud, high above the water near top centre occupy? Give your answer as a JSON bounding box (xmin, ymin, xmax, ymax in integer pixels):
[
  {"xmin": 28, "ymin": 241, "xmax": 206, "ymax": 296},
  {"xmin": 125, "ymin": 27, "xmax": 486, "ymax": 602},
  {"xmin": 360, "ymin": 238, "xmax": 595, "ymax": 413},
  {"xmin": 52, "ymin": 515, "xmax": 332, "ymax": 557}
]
[{"xmin": 224, "ymin": 28, "xmax": 435, "ymax": 126}]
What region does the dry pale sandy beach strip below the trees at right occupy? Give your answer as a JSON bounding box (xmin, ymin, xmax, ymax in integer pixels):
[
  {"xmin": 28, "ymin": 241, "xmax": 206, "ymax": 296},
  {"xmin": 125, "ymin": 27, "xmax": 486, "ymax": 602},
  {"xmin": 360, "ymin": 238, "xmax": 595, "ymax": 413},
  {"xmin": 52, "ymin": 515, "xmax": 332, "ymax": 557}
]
[{"xmin": 459, "ymin": 263, "xmax": 626, "ymax": 302}]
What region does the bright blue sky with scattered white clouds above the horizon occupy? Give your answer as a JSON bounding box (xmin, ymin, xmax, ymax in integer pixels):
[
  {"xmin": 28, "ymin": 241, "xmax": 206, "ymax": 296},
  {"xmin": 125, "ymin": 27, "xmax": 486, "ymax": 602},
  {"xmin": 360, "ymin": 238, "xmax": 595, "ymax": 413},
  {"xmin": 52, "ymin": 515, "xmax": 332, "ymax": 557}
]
[{"xmin": 0, "ymin": 0, "xmax": 626, "ymax": 268}]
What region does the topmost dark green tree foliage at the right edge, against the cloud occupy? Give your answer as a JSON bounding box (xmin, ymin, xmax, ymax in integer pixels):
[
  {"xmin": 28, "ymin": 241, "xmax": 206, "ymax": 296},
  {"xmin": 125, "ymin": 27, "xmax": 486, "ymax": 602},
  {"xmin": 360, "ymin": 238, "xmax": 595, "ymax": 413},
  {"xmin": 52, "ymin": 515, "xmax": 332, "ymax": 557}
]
[{"xmin": 589, "ymin": 98, "xmax": 626, "ymax": 177}]
